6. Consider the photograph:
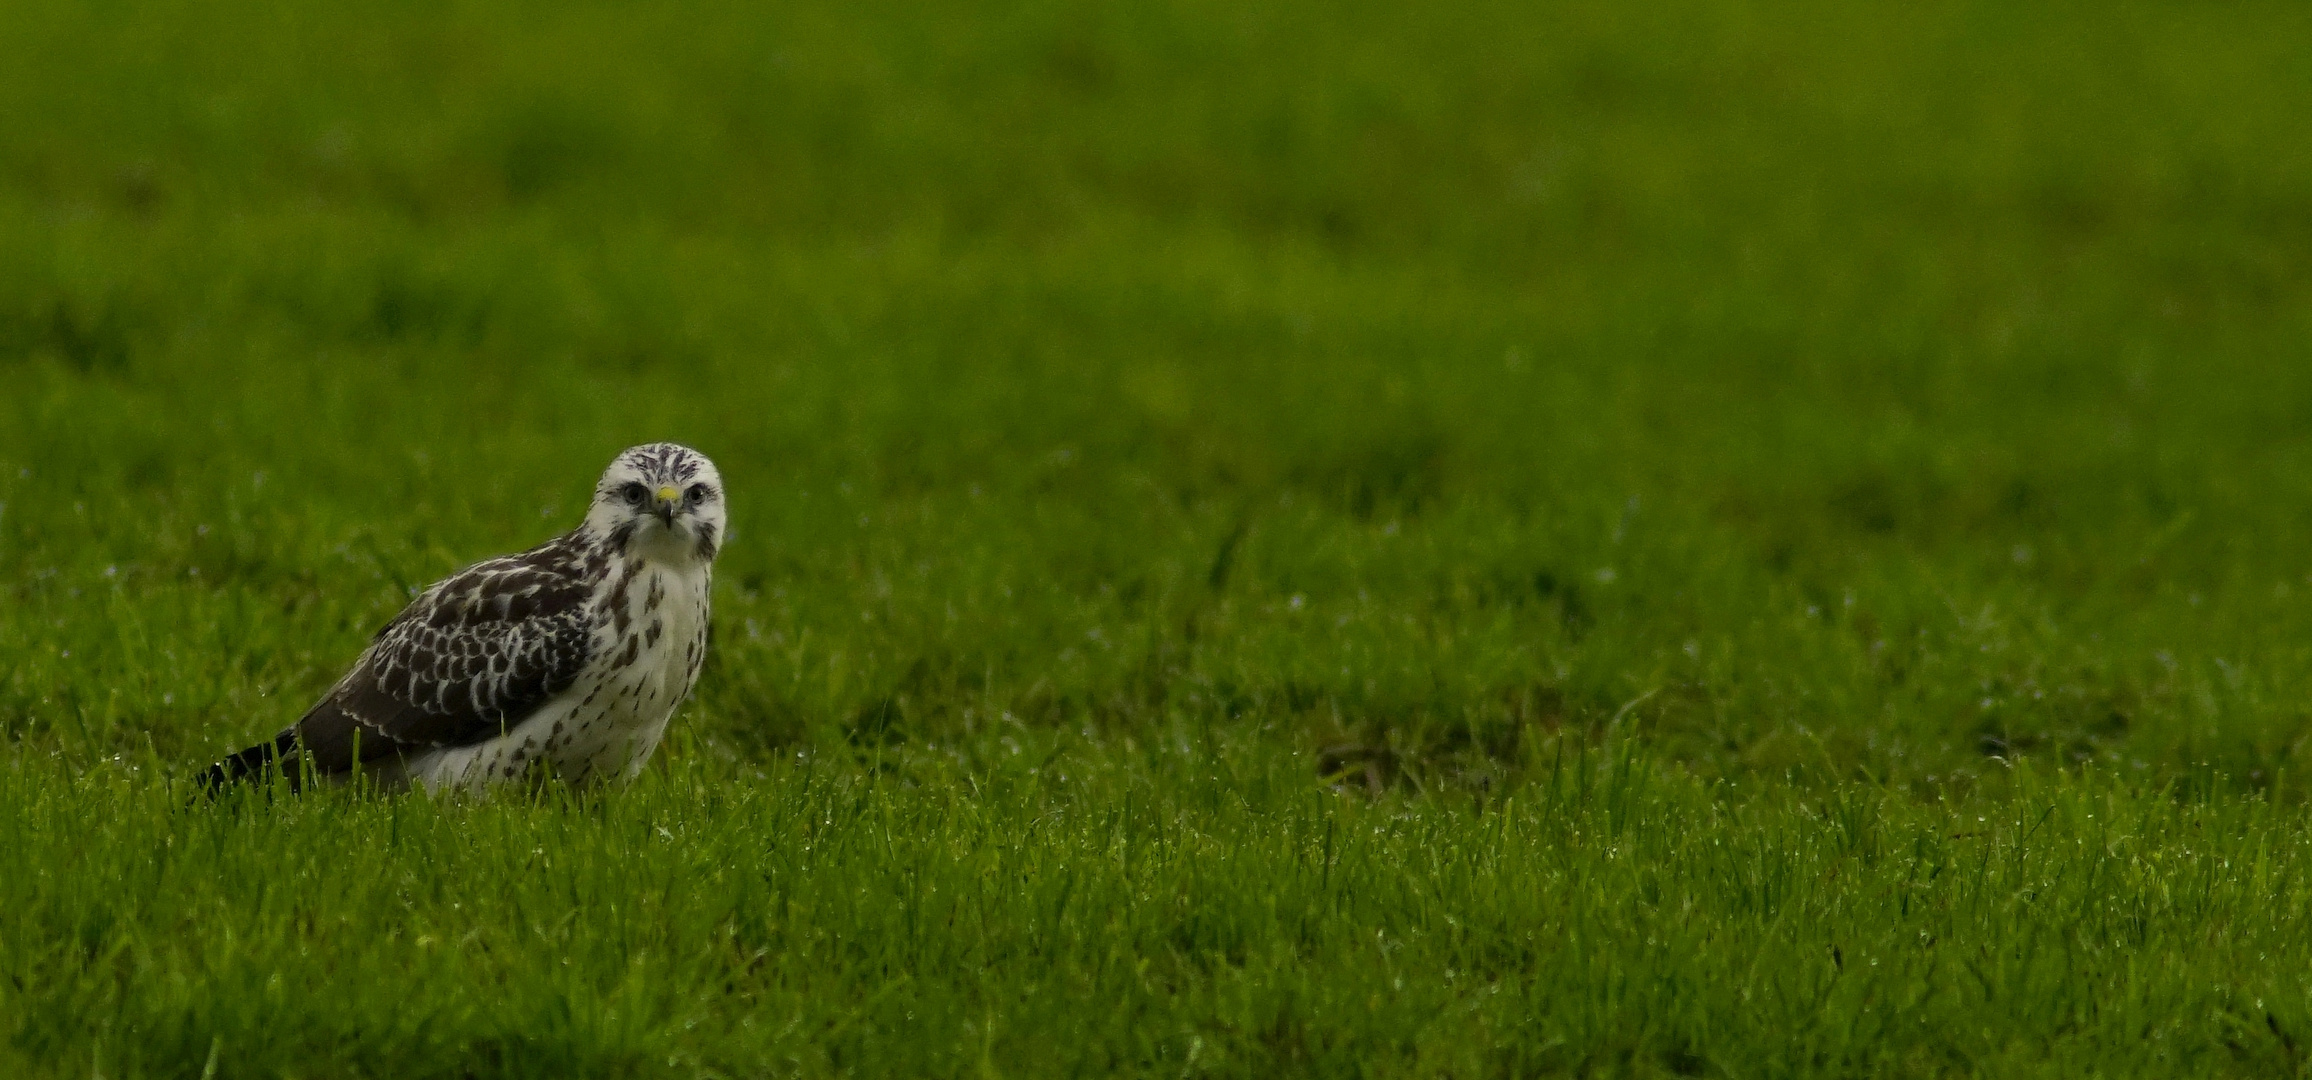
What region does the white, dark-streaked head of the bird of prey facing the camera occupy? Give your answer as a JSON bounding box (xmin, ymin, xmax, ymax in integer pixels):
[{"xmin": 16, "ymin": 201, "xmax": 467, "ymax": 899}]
[{"xmin": 585, "ymin": 442, "xmax": 728, "ymax": 562}]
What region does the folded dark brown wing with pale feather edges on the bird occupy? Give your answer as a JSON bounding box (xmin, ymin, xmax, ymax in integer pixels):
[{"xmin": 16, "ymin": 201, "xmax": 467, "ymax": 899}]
[{"xmin": 294, "ymin": 543, "xmax": 592, "ymax": 772}]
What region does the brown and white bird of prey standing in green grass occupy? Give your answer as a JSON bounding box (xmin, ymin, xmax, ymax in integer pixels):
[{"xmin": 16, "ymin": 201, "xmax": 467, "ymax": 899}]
[{"xmin": 197, "ymin": 442, "xmax": 728, "ymax": 796}]
